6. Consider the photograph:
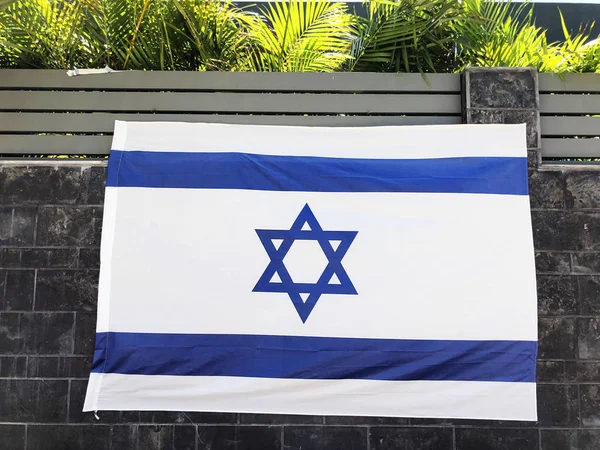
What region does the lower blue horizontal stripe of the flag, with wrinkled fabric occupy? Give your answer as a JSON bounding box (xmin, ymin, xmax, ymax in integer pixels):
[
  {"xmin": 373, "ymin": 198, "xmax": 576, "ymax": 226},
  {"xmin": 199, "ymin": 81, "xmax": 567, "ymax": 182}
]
[{"xmin": 92, "ymin": 332, "xmax": 537, "ymax": 382}]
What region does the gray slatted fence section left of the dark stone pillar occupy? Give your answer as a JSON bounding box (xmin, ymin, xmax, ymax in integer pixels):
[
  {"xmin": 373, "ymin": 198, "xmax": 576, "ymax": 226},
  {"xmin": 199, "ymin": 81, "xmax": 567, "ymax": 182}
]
[{"xmin": 0, "ymin": 70, "xmax": 461, "ymax": 155}]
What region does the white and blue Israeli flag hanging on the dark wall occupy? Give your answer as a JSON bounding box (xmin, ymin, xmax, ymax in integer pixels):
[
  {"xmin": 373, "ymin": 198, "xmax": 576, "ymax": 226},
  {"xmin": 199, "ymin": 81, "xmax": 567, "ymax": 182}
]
[{"xmin": 84, "ymin": 122, "xmax": 537, "ymax": 420}]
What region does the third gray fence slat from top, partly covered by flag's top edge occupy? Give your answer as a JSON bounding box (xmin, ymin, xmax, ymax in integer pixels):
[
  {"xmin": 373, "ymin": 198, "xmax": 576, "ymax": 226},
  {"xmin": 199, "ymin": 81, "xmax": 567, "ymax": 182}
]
[{"xmin": 0, "ymin": 113, "xmax": 461, "ymax": 133}]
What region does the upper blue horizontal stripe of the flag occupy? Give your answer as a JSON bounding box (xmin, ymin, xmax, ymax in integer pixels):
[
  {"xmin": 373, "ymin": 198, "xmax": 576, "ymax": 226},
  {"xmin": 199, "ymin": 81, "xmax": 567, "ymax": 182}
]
[{"xmin": 107, "ymin": 150, "xmax": 528, "ymax": 195}]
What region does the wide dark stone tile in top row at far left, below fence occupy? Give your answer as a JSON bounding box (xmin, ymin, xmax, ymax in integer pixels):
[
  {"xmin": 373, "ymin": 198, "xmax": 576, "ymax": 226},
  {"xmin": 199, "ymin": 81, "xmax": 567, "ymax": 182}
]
[{"xmin": 2, "ymin": 165, "xmax": 83, "ymax": 204}]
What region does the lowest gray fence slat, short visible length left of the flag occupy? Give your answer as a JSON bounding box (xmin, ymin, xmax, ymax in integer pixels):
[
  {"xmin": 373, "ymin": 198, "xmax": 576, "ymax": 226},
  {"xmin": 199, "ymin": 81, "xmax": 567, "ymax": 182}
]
[{"xmin": 0, "ymin": 134, "xmax": 112, "ymax": 155}]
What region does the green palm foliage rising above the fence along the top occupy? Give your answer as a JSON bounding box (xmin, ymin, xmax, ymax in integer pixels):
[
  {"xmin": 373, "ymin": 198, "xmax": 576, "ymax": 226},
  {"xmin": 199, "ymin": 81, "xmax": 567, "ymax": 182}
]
[{"xmin": 0, "ymin": 0, "xmax": 600, "ymax": 73}]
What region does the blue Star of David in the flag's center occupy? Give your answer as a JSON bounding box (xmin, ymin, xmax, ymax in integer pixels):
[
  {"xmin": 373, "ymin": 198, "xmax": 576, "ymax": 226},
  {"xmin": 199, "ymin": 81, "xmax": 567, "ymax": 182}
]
[{"xmin": 252, "ymin": 204, "xmax": 358, "ymax": 323}]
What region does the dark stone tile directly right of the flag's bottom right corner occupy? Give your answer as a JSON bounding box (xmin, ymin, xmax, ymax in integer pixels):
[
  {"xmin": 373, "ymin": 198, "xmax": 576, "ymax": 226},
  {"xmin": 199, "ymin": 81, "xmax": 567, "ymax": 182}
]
[{"xmin": 537, "ymin": 384, "xmax": 579, "ymax": 427}]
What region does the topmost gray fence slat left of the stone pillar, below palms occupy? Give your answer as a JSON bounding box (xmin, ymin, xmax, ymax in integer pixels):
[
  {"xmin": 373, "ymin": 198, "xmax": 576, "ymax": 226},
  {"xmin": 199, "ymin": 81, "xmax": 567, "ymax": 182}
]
[{"xmin": 0, "ymin": 69, "xmax": 460, "ymax": 92}]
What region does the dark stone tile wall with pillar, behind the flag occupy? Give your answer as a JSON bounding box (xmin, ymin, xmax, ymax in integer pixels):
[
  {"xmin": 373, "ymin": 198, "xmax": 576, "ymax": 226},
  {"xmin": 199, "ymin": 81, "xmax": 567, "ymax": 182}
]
[{"xmin": 0, "ymin": 67, "xmax": 600, "ymax": 450}]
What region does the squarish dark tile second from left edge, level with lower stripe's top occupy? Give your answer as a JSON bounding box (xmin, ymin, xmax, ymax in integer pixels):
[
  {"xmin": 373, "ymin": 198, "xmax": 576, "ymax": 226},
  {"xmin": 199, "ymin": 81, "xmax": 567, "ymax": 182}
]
[{"xmin": 20, "ymin": 313, "xmax": 74, "ymax": 355}]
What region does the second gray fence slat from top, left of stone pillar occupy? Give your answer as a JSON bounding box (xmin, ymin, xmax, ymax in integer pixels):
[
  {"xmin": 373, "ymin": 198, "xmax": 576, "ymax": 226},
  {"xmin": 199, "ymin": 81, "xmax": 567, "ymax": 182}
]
[{"xmin": 0, "ymin": 91, "xmax": 460, "ymax": 114}]
